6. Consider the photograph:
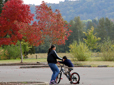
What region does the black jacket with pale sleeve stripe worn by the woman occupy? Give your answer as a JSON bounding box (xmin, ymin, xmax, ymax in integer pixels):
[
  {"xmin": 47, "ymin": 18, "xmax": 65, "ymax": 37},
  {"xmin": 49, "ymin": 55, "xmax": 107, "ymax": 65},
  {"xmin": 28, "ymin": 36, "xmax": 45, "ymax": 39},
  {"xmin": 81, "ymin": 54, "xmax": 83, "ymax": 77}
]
[{"xmin": 47, "ymin": 50, "xmax": 62, "ymax": 63}]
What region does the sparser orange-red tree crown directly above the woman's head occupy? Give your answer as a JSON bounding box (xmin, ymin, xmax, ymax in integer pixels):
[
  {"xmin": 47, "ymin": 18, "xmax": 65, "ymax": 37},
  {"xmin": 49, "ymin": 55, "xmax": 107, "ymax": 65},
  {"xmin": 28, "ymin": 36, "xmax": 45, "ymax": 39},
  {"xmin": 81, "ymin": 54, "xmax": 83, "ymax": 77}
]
[{"xmin": 36, "ymin": 2, "xmax": 72, "ymax": 45}]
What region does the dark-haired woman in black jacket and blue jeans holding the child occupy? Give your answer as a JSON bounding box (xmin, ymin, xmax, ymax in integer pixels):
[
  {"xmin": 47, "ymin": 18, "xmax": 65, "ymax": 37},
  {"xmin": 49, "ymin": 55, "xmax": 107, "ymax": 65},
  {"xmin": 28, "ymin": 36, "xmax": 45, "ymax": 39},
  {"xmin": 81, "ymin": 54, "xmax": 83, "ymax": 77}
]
[{"xmin": 47, "ymin": 45, "xmax": 62, "ymax": 84}]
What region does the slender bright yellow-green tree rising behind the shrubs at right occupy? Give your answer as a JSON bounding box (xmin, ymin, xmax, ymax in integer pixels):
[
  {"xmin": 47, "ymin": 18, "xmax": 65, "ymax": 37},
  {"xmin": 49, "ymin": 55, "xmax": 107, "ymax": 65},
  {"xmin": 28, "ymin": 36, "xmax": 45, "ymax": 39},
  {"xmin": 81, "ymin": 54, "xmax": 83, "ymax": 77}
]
[{"xmin": 84, "ymin": 27, "xmax": 100, "ymax": 50}]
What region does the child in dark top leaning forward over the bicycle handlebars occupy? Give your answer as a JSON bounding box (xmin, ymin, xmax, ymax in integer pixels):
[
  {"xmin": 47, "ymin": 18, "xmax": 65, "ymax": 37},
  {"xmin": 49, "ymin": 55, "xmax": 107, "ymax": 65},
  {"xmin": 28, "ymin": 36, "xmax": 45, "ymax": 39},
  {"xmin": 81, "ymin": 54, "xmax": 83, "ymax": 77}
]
[{"xmin": 60, "ymin": 56, "xmax": 74, "ymax": 76}]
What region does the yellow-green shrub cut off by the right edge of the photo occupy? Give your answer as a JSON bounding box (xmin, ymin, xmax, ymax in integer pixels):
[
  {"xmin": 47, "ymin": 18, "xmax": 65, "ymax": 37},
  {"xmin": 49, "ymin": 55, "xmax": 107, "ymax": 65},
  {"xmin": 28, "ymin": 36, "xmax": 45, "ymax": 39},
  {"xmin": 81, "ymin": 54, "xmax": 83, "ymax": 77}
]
[{"xmin": 100, "ymin": 40, "xmax": 114, "ymax": 61}]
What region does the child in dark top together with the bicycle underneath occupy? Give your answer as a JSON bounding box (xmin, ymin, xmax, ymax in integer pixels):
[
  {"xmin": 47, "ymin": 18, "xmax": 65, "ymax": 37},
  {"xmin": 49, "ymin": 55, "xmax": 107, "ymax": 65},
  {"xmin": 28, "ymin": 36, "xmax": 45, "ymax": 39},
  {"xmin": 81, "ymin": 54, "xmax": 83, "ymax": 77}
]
[{"xmin": 57, "ymin": 56, "xmax": 80, "ymax": 84}]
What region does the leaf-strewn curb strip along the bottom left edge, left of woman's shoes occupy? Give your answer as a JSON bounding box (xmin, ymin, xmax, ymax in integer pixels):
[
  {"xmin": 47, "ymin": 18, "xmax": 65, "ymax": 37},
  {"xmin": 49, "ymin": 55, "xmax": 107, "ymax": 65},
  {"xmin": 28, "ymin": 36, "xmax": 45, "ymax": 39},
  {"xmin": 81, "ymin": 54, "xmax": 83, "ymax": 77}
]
[{"xmin": 0, "ymin": 82, "xmax": 49, "ymax": 85}]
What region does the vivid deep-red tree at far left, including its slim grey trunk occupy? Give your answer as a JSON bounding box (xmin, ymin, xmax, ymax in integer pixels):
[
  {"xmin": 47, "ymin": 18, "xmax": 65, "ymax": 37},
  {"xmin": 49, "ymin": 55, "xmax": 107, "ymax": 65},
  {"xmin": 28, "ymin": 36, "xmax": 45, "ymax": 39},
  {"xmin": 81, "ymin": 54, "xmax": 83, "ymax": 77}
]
[{"xmin": 0, "ymin": 0, "xmax": 42, "ymax": 62}]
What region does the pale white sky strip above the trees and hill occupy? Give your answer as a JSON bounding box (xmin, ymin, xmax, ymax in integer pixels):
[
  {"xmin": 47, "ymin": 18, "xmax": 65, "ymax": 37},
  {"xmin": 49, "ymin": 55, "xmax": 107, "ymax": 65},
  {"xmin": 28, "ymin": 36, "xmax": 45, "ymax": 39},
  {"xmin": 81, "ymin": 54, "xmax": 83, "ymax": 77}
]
[{"xmin": 23, "ymin": 0, "xmax": 64, "ymax": 5}]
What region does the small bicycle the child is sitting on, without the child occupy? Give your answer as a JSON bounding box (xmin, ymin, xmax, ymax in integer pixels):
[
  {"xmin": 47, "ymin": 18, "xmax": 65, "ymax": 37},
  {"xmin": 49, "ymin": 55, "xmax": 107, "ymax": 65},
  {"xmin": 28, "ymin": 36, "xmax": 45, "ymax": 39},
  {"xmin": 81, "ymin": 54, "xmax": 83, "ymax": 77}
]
[{"xmin": 56, "ymin": 65, "xmax": 80, "ymax": 84}]
